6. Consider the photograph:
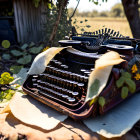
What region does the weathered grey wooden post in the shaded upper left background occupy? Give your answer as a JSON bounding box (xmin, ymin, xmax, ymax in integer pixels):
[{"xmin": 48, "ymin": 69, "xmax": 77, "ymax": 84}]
[{"xmin": 13, "ymin": 0, "xmax": 46, "ymax": 43}]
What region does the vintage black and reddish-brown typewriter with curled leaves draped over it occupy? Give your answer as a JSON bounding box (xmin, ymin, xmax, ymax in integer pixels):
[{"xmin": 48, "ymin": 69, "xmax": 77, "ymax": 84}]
[{"xmin": 23, "ymin": 28, "xmax": 140, "ymax": 119}]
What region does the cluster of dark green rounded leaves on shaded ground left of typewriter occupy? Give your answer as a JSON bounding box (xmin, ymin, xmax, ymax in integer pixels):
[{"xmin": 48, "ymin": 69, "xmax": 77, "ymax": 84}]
[{"xmin": 0, "ymin": 42, "xmax": 44, "ymax": 74}]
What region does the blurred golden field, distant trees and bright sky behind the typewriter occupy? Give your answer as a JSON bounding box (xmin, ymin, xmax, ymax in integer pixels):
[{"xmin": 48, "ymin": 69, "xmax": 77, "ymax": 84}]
[{"xmin": 68, "ymin": 0, "xmax": 132, "ymax": 37}]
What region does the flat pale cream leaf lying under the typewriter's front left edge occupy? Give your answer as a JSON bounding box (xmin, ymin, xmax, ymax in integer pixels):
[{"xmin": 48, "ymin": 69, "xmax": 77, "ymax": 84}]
[{"xmin": 2, "ymin": 92, "xmax": 67, "ymax": 130}]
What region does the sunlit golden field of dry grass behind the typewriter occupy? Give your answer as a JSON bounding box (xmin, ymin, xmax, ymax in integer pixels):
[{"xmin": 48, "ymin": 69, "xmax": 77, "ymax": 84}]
[{"xmin": 73, "ymin": 17, "xmax": 132, "ymax": 37}]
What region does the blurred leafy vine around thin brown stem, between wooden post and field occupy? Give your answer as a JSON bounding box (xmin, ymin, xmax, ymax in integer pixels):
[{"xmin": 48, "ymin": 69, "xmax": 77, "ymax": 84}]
[{"xmin": 44, "ymin": 4, "xmax": 72, "ymax": 46}]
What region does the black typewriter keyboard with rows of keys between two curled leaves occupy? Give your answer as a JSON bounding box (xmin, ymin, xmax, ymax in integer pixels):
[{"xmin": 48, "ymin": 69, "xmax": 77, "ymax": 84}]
[{"xmin": 32, "ymin": 50, "xmax": 96, "ymax": 109}]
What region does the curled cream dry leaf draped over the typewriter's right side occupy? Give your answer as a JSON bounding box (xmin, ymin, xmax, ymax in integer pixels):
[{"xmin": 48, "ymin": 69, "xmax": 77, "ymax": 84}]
[{"xmin": 86, "ymin": 51, "xmax": 125, "ymax": 101}]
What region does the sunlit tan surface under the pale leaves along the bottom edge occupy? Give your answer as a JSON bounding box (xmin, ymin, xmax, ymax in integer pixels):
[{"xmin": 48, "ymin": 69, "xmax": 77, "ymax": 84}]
[{"xmin": 0, "ymin": 113, "xmax": 140, "ymax": 140}]
